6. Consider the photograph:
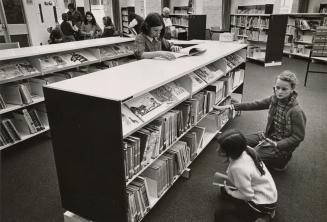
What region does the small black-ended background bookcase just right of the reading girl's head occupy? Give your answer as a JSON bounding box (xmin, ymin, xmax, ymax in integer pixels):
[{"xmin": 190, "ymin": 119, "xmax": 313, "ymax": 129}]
[{"xmin": 170, "ymin": 7, "xmax": 207, "ymax": 40}]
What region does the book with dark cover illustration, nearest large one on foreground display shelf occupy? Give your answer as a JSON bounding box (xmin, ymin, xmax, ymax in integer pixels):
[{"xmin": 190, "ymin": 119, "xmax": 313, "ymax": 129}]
[{"xmin": 125, "ymin": 93, "xmax": 166, "ymax": 122}]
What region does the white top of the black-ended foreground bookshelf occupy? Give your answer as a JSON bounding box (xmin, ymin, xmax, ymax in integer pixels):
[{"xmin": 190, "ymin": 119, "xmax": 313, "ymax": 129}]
[{"xmin": 46, "ymin": 40, "xmax": 247, "ymax": 101}]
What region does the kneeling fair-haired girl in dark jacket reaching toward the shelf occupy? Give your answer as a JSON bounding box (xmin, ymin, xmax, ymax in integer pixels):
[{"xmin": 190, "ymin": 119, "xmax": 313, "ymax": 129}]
[{"xmin": 214, "ymin": 71, "xmax": 306, "ymax": 171}]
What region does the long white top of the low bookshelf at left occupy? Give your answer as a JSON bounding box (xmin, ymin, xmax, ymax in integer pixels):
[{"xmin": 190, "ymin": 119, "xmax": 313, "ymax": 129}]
[{"xmin": 0, "ymin": 37, "xmax": 134, "ymax": 61}]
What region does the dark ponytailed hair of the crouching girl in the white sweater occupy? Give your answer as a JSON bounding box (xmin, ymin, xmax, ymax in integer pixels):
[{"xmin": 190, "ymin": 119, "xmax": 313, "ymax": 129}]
[{"xmin": 218, "ymin": 129, "xmax": 265, "ymax": 175}]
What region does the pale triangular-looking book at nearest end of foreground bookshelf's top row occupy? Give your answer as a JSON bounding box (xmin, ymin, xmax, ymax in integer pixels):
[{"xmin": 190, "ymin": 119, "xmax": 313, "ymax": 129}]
[{"xmin": 121, "ymin": 104, "xmax": 142, "ymax": 135}]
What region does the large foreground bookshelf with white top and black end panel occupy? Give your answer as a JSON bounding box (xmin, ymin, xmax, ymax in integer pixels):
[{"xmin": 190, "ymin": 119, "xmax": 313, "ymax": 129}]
[{"xmin": 44, "ymin": 41, "xmax": 246, "ymax": 221}]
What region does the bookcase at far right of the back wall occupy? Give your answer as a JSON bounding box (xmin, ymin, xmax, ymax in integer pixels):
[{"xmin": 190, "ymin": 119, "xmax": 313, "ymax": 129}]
[{"xmin": 283, "ymin": 13, "xmax": 327, "ymax": 58}]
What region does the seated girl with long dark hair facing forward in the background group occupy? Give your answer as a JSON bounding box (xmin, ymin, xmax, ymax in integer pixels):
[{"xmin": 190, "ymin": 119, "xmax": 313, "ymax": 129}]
[{"xmin": 81, "ymin": 11, "xmax": 102, "ymax": 39}]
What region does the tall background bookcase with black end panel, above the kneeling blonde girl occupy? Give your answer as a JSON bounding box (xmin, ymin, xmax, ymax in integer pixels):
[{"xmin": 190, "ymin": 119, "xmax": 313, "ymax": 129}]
[{"xmin": 230, "ymin": 14, "xmax": 287, "ymax": 66}]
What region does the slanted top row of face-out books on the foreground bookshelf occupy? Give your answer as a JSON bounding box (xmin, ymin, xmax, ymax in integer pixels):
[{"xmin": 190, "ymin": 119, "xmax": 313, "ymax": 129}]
[{"xmin": 122, "ymin": 54, "xmax": 244, "ymax": 135}]
